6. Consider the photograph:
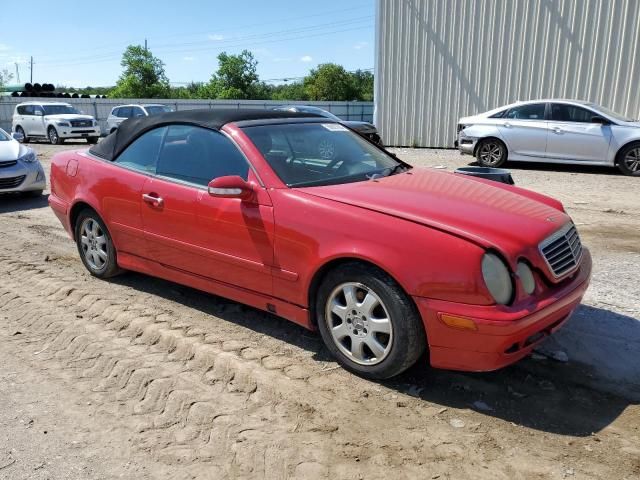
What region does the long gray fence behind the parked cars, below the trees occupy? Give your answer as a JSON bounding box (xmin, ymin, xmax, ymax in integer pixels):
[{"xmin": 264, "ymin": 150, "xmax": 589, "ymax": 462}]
[{"xmin": 0, "ymin": 97, "xmax": 373, "ymax": 132}]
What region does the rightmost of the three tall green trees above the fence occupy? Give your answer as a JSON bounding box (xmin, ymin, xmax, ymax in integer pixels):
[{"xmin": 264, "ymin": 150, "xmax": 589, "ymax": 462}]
[{"xmin": 303, "ymin": 63, "xmax": 357, "ymax": 101}]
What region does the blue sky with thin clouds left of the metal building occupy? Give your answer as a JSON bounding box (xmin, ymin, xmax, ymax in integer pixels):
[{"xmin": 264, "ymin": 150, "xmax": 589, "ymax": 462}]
[{"xmin": 0, "ymin": 0, "xmax": 375, "ymax": 87}]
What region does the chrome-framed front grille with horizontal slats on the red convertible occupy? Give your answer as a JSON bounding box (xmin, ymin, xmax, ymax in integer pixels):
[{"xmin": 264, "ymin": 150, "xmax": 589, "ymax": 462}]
[{"xmin": 540, "ymin": 223, "xmax": 582, "ymax": 278}]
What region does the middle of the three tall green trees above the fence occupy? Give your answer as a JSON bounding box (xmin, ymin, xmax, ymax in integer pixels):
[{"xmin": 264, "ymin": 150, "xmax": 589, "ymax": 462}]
[{"xmin": 201, "ymin": 50, "xmax": 265, "ymax": 99}]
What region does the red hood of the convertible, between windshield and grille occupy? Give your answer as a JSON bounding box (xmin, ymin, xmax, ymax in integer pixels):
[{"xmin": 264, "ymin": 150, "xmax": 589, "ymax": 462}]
[{"xmin": 300, "ymin": 168, "xmax": 570, "ymax": 255}]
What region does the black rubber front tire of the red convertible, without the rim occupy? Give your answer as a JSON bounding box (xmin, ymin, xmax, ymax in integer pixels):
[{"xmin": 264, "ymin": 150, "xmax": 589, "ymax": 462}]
[{"xmin": 315, "ymin": 264, "xmax": 427, "ymax": 380}]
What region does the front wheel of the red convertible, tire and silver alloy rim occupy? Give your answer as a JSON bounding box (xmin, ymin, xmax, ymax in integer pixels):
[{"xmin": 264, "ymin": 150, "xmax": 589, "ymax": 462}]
[{"xmin": 315, "ymin": 263, "xmax": 427, "ymax": 380}]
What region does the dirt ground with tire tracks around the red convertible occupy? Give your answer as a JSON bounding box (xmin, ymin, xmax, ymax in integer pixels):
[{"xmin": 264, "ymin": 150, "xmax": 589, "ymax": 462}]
[{"xmin": 0, "ymin": 144, "xmax": 640, "ymax": 480}]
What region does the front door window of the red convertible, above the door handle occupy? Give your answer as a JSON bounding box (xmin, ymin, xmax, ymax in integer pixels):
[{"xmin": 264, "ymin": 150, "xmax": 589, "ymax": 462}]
[{"xmin": 156, "ymin": 125, "xmax": 249, "ymax": 186}]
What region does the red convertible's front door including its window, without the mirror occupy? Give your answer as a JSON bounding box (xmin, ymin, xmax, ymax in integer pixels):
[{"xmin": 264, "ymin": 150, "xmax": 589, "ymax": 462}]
[{"xmin": 142, "ymin": 125, "xmax": 273, "ymax": 294}]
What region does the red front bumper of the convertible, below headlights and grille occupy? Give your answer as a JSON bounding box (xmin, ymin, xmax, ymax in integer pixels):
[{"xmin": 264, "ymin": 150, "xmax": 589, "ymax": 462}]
[{"xmin": 414, "ymin": 248, "xmax": 591, "ymax": 372}]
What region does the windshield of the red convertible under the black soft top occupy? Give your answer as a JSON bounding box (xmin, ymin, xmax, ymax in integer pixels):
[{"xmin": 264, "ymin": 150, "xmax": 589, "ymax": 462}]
[{"xmin": 244, "ymin": 123, "xmax": 411, "ymax": 187}]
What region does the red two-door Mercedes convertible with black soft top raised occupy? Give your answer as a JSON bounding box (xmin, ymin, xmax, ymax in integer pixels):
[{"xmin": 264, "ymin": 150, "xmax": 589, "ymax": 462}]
[{"xmin": 49, "ymin": 110, "xmax": 591, "ymax": 378}]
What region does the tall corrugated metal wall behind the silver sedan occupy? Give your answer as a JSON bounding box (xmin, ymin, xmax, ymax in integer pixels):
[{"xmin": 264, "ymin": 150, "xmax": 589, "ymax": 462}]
[{"xmin": 375, "ymin": 0, "xmax": 640, "ymax": 147}]
